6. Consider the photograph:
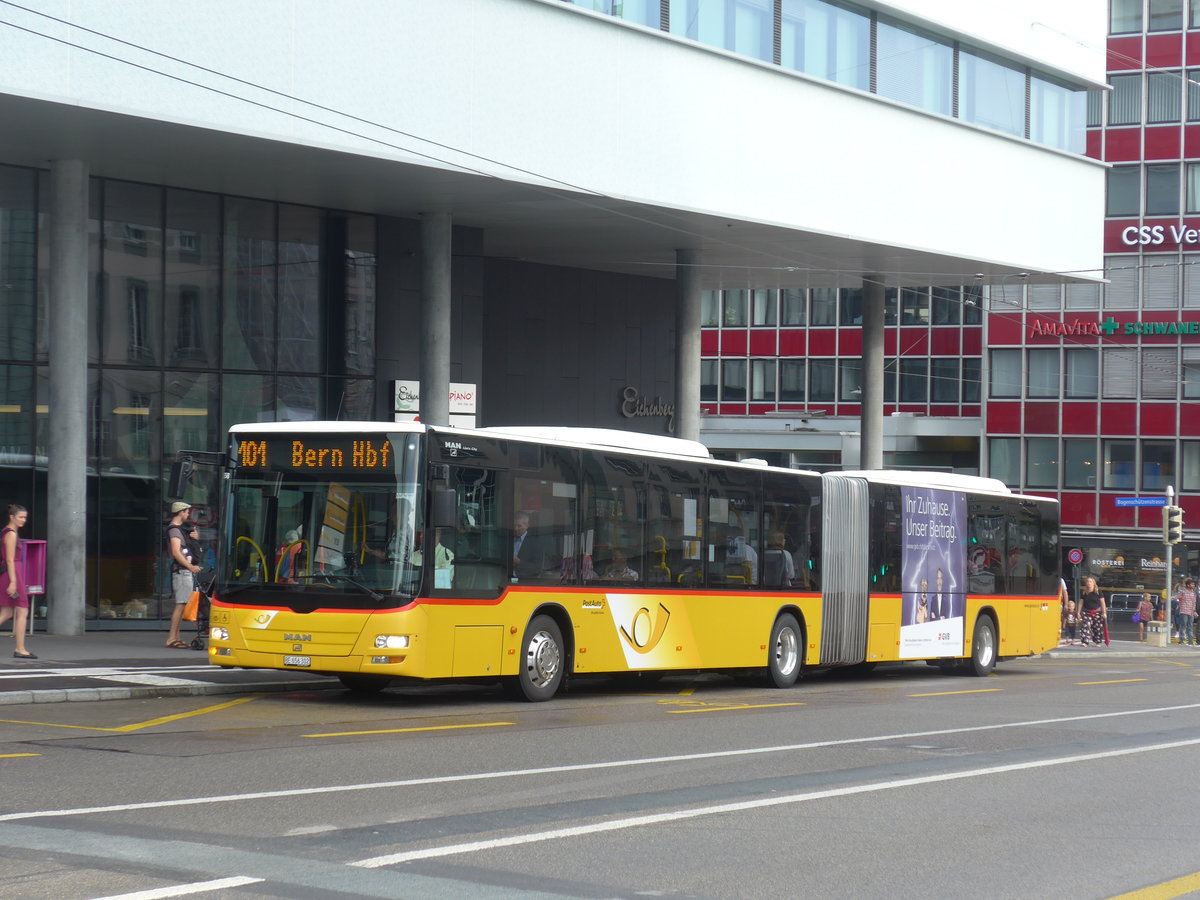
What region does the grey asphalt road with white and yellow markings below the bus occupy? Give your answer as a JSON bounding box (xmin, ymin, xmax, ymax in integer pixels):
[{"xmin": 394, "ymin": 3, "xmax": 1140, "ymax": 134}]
[{"xmin": 0, "ymin": 656, "xmax": 1200, "ymax": 900}]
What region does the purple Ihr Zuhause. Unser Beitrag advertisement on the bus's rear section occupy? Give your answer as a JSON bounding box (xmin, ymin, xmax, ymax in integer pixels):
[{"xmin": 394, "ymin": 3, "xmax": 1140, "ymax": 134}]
[{"xmin": 900, "ymin": 487, "xmax": 967, "ymax": 659}]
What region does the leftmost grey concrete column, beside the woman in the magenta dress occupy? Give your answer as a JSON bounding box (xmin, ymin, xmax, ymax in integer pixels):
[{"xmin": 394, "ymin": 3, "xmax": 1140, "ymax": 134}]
[{"xmin": 46, "ymin": 160, "xmax": 88, "ymax": 635}]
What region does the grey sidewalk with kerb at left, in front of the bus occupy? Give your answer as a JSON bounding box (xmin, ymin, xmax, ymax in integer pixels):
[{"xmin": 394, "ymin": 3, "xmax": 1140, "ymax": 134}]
[{"xmin": 0, "ymin": 629, "xmax": 341, "ymax": 707}]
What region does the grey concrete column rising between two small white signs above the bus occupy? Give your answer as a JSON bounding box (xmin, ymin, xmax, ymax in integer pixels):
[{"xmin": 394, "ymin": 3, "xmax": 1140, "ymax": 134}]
[{"xmin": 420, "ymin": 212, "xmax": 452, "ymax": 425}]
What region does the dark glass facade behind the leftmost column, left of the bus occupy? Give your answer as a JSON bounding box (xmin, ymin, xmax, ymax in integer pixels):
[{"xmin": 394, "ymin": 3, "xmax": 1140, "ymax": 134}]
[{"xmin": 0, "ymin": 166, "xmax": 376, "ymax": 618}]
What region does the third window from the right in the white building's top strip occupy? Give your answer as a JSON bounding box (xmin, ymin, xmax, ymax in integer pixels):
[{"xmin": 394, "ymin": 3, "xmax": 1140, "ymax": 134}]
[{"xmin": 875, "ymin": 19, "xmax": 950, "ymax": 115}]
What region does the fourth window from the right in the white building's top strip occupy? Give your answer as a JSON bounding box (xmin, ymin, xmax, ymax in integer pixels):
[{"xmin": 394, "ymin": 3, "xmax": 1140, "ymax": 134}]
[{"xmin": 780, "ymin": 0, "xmax": 871, "ymax": 91}]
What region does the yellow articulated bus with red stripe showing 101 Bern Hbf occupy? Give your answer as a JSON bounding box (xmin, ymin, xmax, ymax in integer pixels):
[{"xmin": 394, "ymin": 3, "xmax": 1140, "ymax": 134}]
[{"xmin": 209, "ymin": 422, "xmax": 1060, "ymax": 701}]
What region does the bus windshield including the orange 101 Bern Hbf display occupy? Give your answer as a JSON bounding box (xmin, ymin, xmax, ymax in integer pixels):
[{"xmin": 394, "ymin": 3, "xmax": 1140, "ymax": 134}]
[{"xmin": 221, "ymin": 433, "xmax": 424, "ymax": 606}]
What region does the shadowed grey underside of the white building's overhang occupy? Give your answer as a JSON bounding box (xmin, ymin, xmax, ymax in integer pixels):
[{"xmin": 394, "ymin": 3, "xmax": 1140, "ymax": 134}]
[{"xmin": 0, "ymin": 94, "xmax": 1098, "ymax": 288}]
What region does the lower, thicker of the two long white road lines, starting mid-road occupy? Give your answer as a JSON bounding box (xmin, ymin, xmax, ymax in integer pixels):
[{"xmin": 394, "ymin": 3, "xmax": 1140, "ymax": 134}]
[{"xmin": 347, "ymin": 738, "xmax": 1200, "ymax": 869}]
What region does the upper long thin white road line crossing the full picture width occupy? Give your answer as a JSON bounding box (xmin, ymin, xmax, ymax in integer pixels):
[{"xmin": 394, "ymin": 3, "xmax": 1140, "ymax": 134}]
[{"xmin": 0, "ymin": 703, "xmax": 1200, "ymax": 822}]
